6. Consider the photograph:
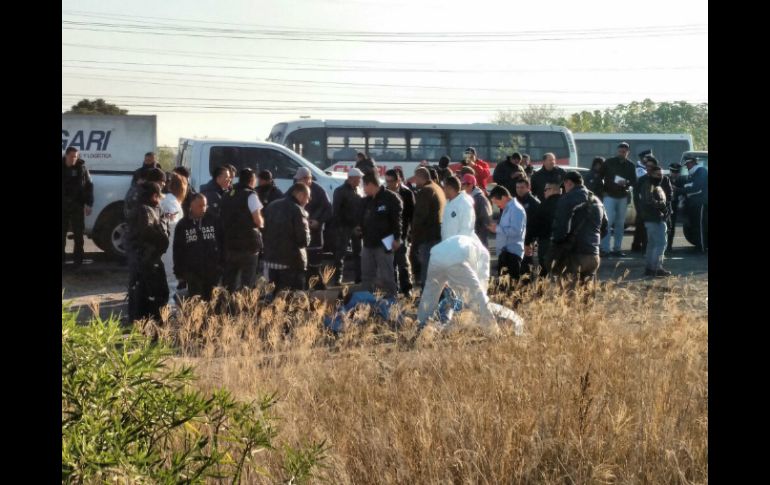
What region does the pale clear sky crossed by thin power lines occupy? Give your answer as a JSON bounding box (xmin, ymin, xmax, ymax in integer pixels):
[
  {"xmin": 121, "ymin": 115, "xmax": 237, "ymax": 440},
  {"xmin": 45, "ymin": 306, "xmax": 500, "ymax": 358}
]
[{"xmin": 62, "ymin": 0, "xmax": 708, "ymax": 146}]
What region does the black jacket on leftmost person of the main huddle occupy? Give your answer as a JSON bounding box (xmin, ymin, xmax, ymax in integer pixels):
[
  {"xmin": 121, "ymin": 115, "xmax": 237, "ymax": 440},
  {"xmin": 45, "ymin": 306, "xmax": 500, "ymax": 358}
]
[{"xmin": 129, "ymin": 204, "xmax": 169, "ymax": 268}]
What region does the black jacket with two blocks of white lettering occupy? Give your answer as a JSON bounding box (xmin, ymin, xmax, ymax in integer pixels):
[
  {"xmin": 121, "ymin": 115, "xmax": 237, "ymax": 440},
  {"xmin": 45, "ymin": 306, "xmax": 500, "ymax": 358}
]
[{"xmin": 174, "ymin": 213, "xmax": 224, "ymax": 281}]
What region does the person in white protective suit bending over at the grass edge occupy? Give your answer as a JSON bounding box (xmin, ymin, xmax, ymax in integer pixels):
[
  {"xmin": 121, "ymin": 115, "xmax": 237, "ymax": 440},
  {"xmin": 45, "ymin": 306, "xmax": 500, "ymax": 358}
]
[{"xmin": 417, "ymin": 234, "xmax": 500, "ymax": 334}]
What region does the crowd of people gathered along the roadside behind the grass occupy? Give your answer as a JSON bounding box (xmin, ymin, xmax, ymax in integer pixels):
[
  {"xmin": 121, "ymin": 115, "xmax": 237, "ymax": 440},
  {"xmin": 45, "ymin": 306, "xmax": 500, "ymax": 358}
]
[{"xmin": 62, "ymin": 143, "xmax": 708, "ymax": 328}]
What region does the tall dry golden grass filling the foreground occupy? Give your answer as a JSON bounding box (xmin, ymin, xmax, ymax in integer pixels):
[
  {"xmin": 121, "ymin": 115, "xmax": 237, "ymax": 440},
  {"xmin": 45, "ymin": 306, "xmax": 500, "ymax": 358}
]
[{"xmin": 135, "ymin": 279, "xmax": 708, "ymax": 484}]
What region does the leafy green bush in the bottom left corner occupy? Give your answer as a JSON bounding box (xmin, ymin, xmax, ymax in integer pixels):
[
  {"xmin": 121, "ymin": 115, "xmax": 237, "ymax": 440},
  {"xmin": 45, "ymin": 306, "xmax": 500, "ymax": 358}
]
[{"xmin": 62, "ymin": 305, "xmax": 325, "ymax": 484}]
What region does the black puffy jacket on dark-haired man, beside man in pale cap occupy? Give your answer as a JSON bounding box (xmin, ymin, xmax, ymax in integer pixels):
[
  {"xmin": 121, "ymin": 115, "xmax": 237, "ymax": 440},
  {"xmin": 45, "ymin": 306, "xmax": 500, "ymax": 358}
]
[{"xmin": 263, "ymin": 194, "xmax": 310, "ymax": 271}]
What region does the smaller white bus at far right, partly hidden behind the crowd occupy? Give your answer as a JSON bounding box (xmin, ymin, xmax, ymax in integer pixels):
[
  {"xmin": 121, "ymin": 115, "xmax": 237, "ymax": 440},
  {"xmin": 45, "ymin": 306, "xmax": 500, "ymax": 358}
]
[{"xmin": 575, "ymin": 133, "xmax": 693, "ymax": 170}]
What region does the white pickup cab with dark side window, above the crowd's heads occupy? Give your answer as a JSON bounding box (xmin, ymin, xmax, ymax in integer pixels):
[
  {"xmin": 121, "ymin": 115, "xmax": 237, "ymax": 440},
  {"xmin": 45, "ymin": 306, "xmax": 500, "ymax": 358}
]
[{"xmin": 177, "ymin": 138, "xmax": 347, "ymax": 201}]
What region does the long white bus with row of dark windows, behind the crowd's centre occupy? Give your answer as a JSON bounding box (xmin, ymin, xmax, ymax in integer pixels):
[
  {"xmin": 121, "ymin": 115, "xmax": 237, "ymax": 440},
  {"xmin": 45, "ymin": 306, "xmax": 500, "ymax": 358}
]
[{"xmin": 267, "ymin": 120, "xmax": 572, "ymax": 178}]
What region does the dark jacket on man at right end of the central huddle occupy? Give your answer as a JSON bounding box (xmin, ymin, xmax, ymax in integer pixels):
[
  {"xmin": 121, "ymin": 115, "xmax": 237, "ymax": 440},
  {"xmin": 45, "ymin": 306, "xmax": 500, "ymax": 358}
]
[{"xmin": 551, "ymin": 186, "xmax": 607, "ymax": 254}]
